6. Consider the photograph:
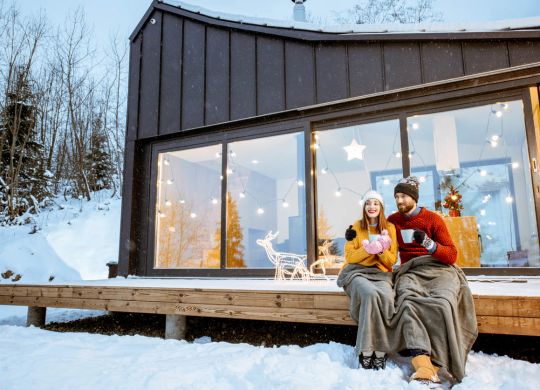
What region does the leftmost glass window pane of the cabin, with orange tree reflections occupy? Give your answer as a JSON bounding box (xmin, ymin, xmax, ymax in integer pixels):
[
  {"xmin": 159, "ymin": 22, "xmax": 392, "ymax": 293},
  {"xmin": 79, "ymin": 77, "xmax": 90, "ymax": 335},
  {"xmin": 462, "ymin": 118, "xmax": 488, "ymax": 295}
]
[{"xmin": 155, "ymin": 145, "xmax": 222, "ymax": 268}]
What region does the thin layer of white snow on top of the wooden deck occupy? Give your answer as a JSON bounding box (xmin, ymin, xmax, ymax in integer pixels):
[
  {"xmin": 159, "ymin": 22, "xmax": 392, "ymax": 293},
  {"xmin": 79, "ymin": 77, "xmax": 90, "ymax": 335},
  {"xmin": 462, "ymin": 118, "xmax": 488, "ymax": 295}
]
[{"xmin": 6, "ymin": 276, "xmax": 540, "ymax": 297}]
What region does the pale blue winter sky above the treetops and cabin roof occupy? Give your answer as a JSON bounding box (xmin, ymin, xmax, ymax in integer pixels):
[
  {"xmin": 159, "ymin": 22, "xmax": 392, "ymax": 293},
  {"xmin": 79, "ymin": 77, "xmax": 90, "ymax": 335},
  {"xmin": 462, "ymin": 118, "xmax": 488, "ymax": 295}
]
[{"xmin": 14, "ymin": 0, "xmax": 540, "ymax": 52}]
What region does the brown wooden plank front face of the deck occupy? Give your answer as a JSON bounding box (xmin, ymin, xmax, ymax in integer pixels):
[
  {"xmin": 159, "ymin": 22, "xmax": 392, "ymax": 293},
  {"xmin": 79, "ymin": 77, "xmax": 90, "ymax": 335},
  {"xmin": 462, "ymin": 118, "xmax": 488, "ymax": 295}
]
[{"xmin": 0, "ymin": 278, "xmax": 540, "ymax": 336}]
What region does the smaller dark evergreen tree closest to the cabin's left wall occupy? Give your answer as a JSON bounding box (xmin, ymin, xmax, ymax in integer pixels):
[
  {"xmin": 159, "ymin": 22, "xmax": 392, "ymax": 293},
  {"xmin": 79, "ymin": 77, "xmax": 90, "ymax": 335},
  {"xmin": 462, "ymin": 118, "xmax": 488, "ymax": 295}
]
[{"xmin": 85, "ymin": 116, "xmax": 114, "ymax": 191}]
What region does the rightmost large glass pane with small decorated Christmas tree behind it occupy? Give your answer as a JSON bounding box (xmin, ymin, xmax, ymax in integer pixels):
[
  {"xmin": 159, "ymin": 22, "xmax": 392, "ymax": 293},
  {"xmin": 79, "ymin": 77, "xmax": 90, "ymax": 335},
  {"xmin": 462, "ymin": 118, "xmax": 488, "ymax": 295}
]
[{"xmin": 407, "ymin": 101, "xmax": 540, "ymax": 267}]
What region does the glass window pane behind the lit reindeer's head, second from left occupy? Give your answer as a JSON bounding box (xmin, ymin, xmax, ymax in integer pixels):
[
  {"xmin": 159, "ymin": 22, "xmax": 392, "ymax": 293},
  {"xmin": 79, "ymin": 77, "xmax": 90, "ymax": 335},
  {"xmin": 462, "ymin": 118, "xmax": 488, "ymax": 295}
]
[{"xmin": 226, "ymin": 132, "xmax": 306, "ymax": 268}]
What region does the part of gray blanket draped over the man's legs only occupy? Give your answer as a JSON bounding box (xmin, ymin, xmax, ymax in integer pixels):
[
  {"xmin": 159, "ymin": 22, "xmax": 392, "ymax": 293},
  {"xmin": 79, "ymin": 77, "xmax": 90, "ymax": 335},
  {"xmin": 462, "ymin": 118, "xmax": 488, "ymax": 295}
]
[{"xmin": 391, "ymin": 256, "xmax": 478, "ymax": 381}]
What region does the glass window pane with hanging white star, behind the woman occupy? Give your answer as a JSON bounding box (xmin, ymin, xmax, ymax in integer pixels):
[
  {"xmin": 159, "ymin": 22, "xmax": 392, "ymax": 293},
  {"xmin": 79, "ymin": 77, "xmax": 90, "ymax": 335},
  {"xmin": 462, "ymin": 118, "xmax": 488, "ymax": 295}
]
[{"xmin": 314, "ymin": 120, "xmax": 403, "ymax": 268}]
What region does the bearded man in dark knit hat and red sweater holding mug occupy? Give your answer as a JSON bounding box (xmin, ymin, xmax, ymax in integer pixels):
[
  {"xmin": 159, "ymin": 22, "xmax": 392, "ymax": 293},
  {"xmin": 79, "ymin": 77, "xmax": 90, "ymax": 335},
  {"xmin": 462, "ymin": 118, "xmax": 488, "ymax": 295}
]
[{"xmin": 388, "ymin": 176, "xmax": 478, "ymax": 384}]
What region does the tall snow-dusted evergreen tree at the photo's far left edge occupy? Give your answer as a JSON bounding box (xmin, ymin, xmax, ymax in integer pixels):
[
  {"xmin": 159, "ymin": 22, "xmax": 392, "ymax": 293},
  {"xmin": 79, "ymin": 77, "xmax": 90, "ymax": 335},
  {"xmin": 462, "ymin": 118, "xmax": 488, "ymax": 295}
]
[{"xmin": 0, "ymin": 68, "xmax": 52, "ymax": 220}]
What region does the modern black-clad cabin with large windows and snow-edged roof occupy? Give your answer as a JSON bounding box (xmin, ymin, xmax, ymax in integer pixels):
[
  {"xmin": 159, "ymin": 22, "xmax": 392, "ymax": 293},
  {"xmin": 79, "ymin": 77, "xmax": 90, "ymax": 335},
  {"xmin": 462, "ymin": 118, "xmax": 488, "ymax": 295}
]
[{"xmin": 119, "ymin": 1, "xmax": 540, "ymax": 277}]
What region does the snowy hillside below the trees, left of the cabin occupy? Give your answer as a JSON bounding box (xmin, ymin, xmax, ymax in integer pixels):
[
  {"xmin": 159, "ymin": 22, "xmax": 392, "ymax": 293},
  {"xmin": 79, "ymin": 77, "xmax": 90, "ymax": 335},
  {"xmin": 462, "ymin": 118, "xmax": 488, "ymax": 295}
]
[{"xmin": 0, "ymin": 191, "xmax": 121, "ymax": 283}]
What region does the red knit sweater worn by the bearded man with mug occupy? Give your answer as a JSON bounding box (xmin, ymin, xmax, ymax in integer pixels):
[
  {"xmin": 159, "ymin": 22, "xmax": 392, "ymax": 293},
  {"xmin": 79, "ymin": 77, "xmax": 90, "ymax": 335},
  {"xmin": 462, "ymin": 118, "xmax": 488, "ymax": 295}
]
[{"xmin": 388, "ymin": 208, "xmax": 457, "ymax": 264}]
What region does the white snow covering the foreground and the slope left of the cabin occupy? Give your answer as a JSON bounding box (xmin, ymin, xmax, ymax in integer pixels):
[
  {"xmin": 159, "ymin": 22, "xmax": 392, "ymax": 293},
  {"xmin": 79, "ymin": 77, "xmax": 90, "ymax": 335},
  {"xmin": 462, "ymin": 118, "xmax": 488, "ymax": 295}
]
[{"xmin": 0, "ymin": 193, "xmax": 540, "ymax": 390}]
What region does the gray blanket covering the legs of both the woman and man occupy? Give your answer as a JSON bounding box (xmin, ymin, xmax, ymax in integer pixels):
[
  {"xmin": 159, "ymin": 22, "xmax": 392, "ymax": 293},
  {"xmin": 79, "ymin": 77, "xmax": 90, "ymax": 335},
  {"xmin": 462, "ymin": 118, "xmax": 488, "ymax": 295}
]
[{"xmin": 337, "ymin": 256, "xmax": 478, "ymax": 381}]
